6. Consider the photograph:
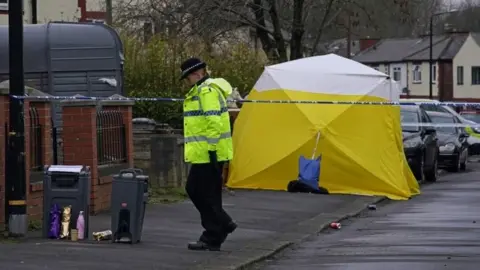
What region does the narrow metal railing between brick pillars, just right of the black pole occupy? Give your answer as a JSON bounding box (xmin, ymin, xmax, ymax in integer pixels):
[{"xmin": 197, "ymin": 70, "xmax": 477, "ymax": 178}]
[{"xmin": 29, "ymin": 107, "xmax": 43, "ymax": 171}]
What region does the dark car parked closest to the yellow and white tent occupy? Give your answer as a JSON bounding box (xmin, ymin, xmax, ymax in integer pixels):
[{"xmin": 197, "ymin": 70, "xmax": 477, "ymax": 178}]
[{"xmin": 401, "ymin": 106, "xmax": 439, "ymax": 182}]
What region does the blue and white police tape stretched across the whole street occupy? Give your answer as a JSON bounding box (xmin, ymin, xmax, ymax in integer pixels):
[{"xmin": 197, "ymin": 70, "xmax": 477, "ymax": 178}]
[{"xmin": 10, "ymin": 95, "xmax": 480, "ymax": 108}]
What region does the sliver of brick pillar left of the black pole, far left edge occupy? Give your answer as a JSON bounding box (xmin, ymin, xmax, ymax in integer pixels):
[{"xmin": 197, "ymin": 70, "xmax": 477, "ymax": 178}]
[{"xmin": 0, "ymin": 90, "xmax": 9, "ymax": 225}]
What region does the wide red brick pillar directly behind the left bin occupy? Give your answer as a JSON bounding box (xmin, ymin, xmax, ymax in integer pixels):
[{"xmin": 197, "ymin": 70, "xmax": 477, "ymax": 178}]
[{"xmin": 62, "ymin": 100, "xmax": 98, "ymax": 212}]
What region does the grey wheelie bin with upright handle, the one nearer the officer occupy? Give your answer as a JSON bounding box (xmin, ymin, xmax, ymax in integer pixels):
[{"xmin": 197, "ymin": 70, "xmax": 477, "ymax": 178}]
[{"xmin": 111, "ymin": 169, "xmax": 148, "ymax": 244}]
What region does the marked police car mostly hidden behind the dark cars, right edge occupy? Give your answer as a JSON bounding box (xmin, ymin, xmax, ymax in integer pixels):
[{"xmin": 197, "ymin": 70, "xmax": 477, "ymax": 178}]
[{"xmin": 400, "ymin": 99, "xmax": 480, "ymax": 155}]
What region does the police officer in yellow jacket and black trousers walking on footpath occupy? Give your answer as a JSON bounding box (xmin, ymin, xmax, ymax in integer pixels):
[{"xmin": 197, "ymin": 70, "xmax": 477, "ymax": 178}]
[{"xmin": 181, "ymin": 58, "xmax": 237, "ymax": 251}]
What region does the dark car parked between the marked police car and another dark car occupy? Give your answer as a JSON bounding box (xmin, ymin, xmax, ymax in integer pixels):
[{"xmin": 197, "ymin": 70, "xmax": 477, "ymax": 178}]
[{"xmin": 427, "ymin": 112, "xmax": 469, "ymax": 172}]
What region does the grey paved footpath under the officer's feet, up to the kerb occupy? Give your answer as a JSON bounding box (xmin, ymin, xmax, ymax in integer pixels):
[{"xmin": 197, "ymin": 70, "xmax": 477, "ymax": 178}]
[{"xmin": 0, "ymin": 191, "xmax": 378, "ymax": 270}]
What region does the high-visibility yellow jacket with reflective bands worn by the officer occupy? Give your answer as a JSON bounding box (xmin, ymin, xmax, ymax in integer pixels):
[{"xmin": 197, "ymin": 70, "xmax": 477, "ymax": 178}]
[{"xmin": 183, "ymin": 78, "xmax": 233, "ymax": 164}]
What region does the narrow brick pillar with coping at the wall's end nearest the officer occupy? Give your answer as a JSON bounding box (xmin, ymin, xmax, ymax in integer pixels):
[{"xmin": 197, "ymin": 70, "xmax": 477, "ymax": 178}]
[{"xmin": 102, "ymin": 98, "xmax": 135, "ymax": 168}]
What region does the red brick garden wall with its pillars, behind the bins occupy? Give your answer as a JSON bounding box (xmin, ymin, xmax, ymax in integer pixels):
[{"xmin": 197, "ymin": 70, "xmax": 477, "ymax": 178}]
[{"xmin": 0, "ymin": 99, "xmax": 133, "ymax": 224}]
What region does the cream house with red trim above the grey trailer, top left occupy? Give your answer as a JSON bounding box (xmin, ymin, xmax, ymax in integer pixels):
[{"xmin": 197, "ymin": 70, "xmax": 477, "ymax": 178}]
[{"xmin": 0, "ymin": 0, "xmax": 105, "ymax": 25}]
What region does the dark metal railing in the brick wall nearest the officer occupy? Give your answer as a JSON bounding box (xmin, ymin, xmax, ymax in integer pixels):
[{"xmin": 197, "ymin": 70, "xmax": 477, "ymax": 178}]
[{"xmin": 97, "ymin": 111, "xmax": 127, "ymax": 165}]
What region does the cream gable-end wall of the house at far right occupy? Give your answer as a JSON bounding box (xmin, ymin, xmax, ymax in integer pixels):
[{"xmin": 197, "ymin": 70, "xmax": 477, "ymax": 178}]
[{"xmin": 452, "ymin": 35, "xmax": 480, "ymax": 99}]
